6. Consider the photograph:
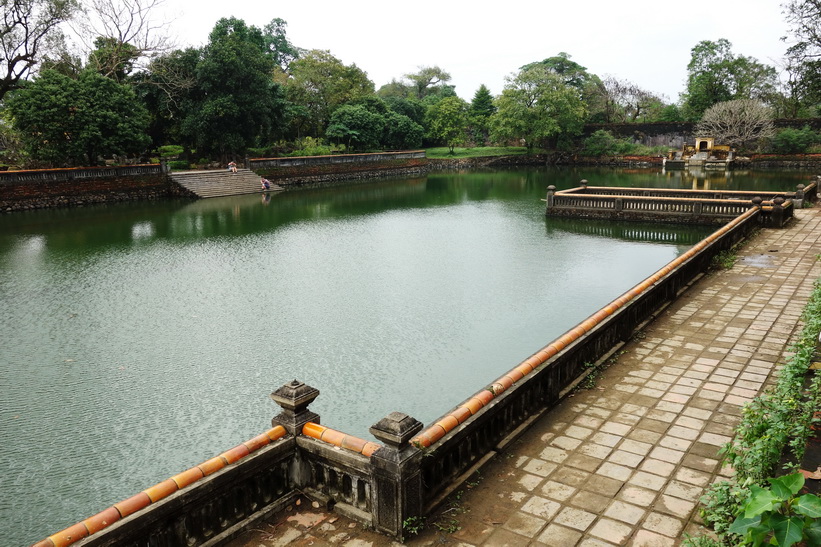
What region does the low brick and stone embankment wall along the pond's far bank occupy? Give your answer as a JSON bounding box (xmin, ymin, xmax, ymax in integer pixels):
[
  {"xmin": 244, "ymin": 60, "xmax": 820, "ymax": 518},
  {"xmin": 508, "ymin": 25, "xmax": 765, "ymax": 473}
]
[{"xmin": 0, "ymin": 150, "xmax": 821, "ymax": 213}]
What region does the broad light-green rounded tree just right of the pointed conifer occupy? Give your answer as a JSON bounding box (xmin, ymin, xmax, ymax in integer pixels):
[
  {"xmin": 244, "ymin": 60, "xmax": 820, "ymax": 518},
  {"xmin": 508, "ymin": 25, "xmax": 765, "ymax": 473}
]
[{"xmin": 491, "ymin": 66, "xmax": 587, "ymax": 152}]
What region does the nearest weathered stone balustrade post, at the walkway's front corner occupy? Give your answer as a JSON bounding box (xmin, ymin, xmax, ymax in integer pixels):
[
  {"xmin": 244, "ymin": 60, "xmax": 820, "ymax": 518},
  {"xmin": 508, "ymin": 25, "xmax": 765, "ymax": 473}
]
[{"xmin": 370, "ymin": 412, "xmax": 422, "ymax": 541}]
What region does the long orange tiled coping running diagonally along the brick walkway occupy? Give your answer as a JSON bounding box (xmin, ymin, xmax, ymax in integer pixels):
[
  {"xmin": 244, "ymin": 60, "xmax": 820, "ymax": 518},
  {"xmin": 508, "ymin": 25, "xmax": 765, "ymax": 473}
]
[{"xmin": 411, "ymin": 209, "xmax": 755, "ymax": 448}]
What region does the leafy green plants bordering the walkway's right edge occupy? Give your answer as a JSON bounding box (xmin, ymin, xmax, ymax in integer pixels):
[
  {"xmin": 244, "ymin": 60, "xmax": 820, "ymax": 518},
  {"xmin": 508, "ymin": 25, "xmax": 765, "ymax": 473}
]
[{"xmin": 688, "ymin": 280, "xmax": 821, "ymax": 546}]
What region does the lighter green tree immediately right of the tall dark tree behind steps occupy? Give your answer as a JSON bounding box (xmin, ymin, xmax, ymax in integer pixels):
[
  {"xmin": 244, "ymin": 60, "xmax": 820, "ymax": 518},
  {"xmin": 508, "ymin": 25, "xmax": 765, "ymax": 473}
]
[{"xmin": 285, "ymin": 49, "xmax": 374, "ymax": 136}]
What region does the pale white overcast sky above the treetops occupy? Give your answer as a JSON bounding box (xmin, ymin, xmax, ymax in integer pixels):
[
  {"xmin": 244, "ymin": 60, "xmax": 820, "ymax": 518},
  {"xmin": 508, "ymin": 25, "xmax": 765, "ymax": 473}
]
[{"xmin": 159, "ymin": 0, "xmax": 787, "ymax": 102}]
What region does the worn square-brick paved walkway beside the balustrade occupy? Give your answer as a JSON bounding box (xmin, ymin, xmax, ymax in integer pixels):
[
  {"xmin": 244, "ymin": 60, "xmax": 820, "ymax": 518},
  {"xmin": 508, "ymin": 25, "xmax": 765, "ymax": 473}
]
[{"xmin": 231, "ymin": 209, "xmax": 821, "ymax": 547}]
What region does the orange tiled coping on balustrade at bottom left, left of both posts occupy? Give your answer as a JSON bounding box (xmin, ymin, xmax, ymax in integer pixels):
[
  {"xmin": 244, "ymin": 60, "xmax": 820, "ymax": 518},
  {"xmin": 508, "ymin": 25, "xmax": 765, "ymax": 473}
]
[{"xmin": 32, "ymin": 425, "xmax": 287, "ymax": 547}]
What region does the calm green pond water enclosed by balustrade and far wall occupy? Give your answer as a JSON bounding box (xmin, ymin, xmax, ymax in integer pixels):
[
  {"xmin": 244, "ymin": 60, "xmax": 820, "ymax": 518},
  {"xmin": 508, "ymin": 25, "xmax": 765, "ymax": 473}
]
[{"xmin": 0, "ymin": 169, "xmax": 808, "ymax": 546}]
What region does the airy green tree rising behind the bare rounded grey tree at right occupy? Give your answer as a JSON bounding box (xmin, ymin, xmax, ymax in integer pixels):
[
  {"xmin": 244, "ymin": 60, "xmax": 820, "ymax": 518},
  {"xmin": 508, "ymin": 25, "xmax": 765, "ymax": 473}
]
[{"xmin": 682, "ymin": 38, "xmax": 777, "ymax": 121}]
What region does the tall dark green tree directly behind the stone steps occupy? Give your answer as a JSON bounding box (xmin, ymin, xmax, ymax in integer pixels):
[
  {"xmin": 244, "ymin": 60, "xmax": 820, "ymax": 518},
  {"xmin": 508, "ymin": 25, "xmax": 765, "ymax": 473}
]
[{"xmin": 182, "ymin": 17, "xmax": 285, "ymax": 159}]
